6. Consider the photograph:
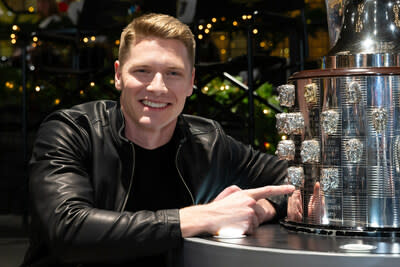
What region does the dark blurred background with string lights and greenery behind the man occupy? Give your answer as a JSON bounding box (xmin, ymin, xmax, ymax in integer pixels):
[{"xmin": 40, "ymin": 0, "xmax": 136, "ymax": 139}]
[{"xmin": 0, "ymin": 0, "xmax": 329, "ymax": 266}]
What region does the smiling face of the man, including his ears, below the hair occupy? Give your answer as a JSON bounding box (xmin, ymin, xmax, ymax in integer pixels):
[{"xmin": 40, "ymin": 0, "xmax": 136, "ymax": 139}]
[{"xmin": 115, "ymin": 37, "xmax": 194, "ymax": 131}]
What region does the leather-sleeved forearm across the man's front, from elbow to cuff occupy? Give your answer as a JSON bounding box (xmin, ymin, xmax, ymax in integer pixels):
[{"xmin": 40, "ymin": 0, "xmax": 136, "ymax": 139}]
[{"xmin": 35, "ymin": 209, "xmax": 181, "ymax": 263}]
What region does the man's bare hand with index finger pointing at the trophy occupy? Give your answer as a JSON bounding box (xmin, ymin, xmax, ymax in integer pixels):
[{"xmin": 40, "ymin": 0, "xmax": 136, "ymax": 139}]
[{"xmin": 180, "ymin": 185, "xmax": 294, "ymax": 237}]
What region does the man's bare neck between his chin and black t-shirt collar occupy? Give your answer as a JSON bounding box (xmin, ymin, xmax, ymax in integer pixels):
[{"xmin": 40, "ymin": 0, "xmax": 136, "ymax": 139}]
[{"xmin": 125, "ymin": 120, "xmax": 176, "ymax": 149}]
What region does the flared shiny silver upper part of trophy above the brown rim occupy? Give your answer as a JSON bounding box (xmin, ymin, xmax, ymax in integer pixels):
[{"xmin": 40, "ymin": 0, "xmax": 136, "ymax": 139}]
[{"xmin": 323, "ymin": 0, "xmax": 400, "ymax": 68}]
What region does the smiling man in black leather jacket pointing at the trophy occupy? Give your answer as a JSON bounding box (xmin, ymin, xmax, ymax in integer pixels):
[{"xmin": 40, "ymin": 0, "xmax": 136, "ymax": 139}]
[{"xmin": 25, "ymin": 14, "xmax": 294, "ymax": 266}]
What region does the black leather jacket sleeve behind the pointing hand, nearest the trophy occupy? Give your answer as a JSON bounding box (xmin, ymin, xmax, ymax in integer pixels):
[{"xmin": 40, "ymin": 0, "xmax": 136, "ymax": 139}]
[{"xmin": 217, "ymin": 124, "xmax": 287, "ymax": 219}]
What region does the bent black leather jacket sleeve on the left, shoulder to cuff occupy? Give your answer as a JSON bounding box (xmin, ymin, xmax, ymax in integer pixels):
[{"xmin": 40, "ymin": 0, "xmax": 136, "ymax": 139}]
[{"xmin": 29, "ymin": 112, "xmax": 181, "ymax": 263}]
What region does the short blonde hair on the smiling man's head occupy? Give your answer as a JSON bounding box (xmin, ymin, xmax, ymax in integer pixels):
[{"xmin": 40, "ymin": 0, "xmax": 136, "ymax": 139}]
[{"xmin": 118, "ymin": 13, "xmax": 196, "ymax": 66}]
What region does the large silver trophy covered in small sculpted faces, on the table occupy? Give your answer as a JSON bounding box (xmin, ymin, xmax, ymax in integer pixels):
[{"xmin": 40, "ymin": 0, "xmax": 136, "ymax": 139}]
[{"xmin": 276, "ymin": 0, "xmax": 400, "ymax": 236}]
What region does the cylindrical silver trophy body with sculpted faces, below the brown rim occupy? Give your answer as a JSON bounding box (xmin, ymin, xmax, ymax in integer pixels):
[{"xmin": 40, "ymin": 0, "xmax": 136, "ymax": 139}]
[{"xmin": 278, "ymin": 68, "xmax": 400, "ymax": 234}]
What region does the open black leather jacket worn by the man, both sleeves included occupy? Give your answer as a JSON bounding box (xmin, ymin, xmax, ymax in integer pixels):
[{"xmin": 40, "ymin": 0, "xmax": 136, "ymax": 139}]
[{"xmin": 25, "ymin": 101, "xmax": 286, "ymax": 266}]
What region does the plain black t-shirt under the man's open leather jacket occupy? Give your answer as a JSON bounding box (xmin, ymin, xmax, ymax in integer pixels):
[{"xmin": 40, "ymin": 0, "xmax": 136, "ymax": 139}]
[{"xmin": 126, "ymin": 137, "xmax": 192, "ymax": 266}]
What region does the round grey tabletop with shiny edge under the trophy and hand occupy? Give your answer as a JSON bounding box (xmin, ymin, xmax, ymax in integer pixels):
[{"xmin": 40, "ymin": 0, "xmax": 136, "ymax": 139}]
[{"xmin": 182, "ymin": 224, "xmax": 400, "ymax": 267}]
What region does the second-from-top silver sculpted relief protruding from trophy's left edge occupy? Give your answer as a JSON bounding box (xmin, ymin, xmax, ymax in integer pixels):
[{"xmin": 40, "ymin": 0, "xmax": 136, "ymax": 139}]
[{"xmin": 276, "ymin": 112, "xmax": 304, "ymax": 134}]
